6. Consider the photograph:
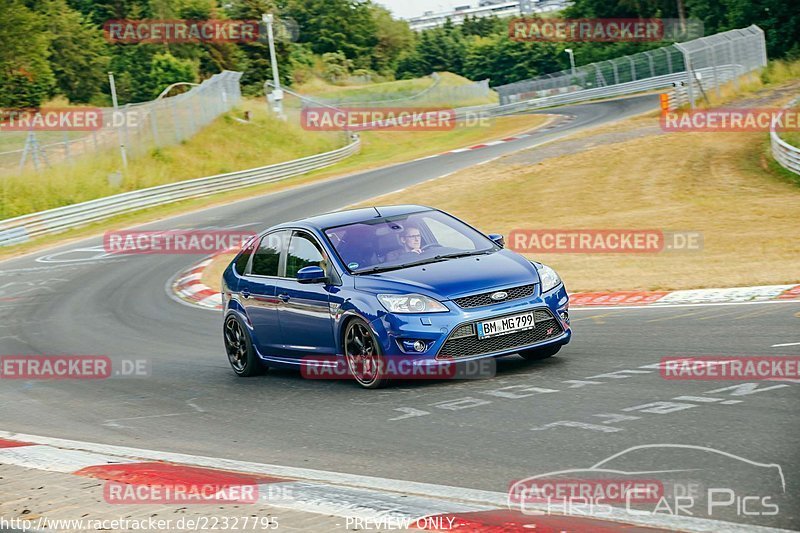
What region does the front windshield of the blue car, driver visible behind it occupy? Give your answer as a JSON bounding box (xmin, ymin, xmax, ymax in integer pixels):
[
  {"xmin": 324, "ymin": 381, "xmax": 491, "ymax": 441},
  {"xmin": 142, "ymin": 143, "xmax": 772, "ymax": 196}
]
[{"xmin": 325, "ymin": 210, "xmax": 498, "ymax": 273}]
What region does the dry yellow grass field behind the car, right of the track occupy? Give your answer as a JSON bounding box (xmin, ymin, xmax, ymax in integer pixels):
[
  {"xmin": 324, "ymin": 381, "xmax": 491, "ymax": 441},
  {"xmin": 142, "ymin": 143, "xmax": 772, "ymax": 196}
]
[{"xmin": 356, "ymin": 117, "xmax": 800, "ymax": 291}]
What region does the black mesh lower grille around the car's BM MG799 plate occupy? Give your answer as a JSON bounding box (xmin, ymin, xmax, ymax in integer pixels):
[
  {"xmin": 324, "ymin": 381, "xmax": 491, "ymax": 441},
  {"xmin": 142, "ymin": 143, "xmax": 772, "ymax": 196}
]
[{"xmin": 436, "ymin": 309, "xmax": 564, "ymax": 359}]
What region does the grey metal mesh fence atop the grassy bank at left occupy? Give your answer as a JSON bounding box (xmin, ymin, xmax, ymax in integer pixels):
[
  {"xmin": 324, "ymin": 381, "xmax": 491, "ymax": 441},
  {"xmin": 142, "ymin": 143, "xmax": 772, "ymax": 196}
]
[{"xmin": 0, "ymin": 71, "xmax": 242, "ymax": 172}]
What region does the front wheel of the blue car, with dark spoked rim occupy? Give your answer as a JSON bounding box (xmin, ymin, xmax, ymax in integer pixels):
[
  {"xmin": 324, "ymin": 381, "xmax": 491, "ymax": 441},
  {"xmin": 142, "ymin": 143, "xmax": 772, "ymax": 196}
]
[{"xmin": 344, "ymin": 318, "xmax": 389, "ymax": 389}]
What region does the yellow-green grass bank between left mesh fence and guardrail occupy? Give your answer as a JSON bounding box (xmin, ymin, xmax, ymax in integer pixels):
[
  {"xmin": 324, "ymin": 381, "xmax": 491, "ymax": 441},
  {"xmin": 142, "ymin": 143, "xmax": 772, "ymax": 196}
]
[{"xmin": 0, "ymin": 100, "xmax": 344, "ymax": 219}]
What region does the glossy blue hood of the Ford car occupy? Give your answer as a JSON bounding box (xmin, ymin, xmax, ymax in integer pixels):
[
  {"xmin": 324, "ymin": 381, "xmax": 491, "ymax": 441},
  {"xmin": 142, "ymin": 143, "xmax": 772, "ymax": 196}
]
[{"xmin": 355, "ymin": 250, "xmax": 539, "ymax": 299}]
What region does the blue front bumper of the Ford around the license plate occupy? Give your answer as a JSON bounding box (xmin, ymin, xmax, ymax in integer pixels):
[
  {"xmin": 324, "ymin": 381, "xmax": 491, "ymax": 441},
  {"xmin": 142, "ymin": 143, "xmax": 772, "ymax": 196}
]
[{"xmin": 372, "ymin": 284, "xmax": 572, "ymax": 364}]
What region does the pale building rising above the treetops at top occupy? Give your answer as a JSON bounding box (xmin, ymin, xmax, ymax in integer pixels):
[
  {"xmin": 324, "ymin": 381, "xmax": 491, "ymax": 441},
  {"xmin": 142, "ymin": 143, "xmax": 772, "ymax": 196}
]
[{"xmin": 408, "ymin": 0, "xmax": 569, "ymax": 31}]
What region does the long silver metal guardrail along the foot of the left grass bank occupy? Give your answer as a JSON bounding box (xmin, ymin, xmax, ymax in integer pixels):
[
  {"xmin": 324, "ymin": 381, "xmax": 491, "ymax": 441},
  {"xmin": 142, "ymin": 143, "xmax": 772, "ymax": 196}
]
[{"xmin": 0, "ymin": 136, "xmax": 361, "ymax": 246}]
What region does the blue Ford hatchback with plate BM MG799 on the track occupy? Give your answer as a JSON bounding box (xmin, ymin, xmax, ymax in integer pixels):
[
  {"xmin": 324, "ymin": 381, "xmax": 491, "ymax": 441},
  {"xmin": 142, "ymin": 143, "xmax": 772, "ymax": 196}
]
[{"xmin": 222, "ymin": 205, "xmax": 572, "ymax": 388}]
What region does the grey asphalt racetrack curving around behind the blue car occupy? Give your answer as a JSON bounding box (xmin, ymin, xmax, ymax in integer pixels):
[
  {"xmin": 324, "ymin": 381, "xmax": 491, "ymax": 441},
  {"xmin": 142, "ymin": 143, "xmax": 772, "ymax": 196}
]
[{"xmin": 0, "ymin": 95, "xmax": 800, "ymax": 528}]
